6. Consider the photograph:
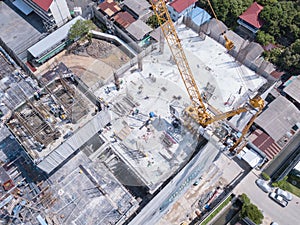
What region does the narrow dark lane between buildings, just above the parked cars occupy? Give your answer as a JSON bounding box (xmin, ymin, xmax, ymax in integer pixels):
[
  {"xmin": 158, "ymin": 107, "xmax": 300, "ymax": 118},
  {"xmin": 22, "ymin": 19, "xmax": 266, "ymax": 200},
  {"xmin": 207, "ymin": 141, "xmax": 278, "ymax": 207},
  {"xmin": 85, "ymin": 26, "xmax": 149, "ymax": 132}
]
[{"xmin": 264, "ymin": 132, "xmax": 300, "ymax": 177}]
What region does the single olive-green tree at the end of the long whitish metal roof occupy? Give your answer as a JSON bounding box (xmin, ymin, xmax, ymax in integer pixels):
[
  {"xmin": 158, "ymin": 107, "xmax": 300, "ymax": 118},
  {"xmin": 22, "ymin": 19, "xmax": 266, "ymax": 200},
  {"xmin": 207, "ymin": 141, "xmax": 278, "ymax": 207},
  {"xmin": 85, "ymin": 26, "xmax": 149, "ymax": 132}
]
[{"xmin": 68, "ymin": 20, "xmax": 96, "ymax": 41}]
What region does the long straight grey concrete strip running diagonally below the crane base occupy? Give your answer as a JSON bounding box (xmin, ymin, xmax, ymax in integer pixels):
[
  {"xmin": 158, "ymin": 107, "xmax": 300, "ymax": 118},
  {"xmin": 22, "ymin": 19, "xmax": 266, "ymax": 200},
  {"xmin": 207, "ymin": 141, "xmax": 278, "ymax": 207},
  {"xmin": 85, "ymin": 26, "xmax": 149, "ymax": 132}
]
[{"xmin": 129, "ymin": 143, "xmax": 219, "ymax": 225}]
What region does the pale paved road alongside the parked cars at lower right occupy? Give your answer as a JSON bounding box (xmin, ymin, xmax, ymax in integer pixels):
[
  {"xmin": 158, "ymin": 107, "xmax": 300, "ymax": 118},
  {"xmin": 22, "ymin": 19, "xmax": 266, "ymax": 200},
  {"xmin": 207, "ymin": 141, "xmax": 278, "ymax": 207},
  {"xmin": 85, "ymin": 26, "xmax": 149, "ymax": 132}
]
[{"xmin": 234, "ymin": 172, "xmax": 300, "ymax": 225}]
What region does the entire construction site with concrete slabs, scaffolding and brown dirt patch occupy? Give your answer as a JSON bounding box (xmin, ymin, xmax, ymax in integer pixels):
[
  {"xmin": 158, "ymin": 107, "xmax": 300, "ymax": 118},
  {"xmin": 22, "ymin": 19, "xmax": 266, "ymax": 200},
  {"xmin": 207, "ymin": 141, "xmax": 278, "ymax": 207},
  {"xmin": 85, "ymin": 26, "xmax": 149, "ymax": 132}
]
[{"xmin": 0, "ymin": 0, "xmax": 274, "ymax": 225}]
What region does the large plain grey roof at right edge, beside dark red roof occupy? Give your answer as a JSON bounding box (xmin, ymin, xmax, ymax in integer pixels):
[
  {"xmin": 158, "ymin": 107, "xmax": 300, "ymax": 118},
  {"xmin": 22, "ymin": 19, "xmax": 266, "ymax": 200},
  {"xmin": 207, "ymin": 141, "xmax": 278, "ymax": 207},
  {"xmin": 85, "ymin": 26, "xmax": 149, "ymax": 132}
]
[{"xmin": 255, "ymin": 95, "xmax": 300, "ymax": 142}]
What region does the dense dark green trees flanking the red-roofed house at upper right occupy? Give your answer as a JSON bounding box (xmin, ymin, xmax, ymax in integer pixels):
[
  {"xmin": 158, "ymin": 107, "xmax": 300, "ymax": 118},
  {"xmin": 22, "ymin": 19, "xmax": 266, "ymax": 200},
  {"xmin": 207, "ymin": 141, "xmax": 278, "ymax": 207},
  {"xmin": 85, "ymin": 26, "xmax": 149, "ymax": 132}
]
[{"xmin": 198, "ymin": 0, "xmax": 300, "ymax": 74}]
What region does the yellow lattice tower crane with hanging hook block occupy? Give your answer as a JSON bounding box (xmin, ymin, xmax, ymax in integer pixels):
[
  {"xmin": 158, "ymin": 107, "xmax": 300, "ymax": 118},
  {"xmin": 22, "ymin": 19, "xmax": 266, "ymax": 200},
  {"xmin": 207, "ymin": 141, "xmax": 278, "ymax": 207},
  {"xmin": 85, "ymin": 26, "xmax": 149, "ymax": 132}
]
[{"xmin": 151, "ymin": 0, "xmax": 264, "ymax": 151}]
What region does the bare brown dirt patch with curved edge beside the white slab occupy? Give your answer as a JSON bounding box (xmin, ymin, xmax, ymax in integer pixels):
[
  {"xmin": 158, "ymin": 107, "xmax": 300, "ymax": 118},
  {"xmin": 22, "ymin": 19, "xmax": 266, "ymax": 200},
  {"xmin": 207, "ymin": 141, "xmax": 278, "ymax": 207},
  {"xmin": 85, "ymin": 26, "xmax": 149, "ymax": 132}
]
[{"xmin": 36, "ymin": 39, "xmax": 130, "ymax": 87}]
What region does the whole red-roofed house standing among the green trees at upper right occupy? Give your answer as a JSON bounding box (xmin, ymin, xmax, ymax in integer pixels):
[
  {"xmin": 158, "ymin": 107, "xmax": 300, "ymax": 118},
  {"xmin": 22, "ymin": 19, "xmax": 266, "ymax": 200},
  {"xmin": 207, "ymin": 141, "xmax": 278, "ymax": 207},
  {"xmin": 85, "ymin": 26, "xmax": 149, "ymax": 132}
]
[{"xmin": 237, "ymin": 2, "xmax": 264, "ymax": 34}]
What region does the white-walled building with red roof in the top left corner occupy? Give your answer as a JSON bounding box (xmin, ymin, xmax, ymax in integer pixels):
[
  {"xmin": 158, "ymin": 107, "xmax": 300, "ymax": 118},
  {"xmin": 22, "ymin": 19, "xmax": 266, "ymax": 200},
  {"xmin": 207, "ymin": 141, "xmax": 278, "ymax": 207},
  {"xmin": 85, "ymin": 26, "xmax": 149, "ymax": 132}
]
[{"xmin": 14, "ymin": 0, "xmax": 71, "ymax": 30}]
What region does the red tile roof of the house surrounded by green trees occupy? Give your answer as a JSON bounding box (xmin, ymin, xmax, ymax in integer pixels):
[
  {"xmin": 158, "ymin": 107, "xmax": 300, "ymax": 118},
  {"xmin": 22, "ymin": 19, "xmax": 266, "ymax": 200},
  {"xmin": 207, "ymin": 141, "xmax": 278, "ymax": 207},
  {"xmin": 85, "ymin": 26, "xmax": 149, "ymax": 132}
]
[{"xmin": 239, "ymin": 2, "xmax": 264, "ymax": 29}]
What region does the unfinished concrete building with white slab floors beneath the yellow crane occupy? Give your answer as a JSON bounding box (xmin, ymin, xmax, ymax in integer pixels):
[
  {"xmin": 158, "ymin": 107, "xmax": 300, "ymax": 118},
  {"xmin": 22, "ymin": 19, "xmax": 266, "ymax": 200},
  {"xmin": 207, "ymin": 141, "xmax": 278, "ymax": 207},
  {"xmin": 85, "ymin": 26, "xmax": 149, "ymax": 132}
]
[{"xmin": 0, "ymin": 3, "xmax": 272, "ymax": 225}]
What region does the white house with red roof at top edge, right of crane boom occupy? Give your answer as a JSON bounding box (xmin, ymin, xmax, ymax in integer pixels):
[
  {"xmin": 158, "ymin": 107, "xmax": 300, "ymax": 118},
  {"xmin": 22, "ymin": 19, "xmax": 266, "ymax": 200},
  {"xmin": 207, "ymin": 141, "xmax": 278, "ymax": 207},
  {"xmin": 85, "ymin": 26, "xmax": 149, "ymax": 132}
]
[{"xmin": 167, "ymin": 0, "xmax": 197, "ymax": 21}]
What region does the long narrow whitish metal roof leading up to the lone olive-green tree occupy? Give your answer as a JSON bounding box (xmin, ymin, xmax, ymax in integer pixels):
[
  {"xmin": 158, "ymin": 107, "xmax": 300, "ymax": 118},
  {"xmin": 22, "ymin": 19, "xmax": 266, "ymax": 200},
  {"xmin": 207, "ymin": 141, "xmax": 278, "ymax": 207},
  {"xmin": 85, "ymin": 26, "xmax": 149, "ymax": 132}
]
[{"xmin": 28, "ymin": 16, "xmax": 84, "ymax": 58}]
